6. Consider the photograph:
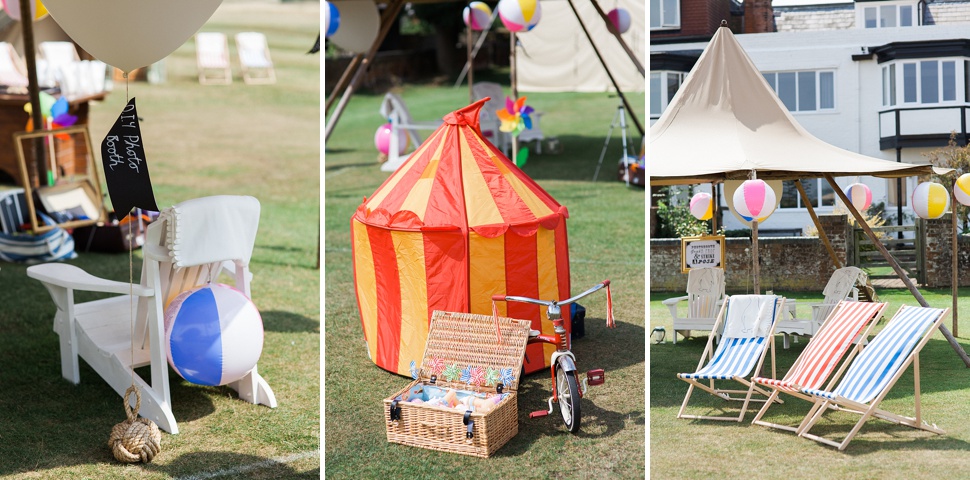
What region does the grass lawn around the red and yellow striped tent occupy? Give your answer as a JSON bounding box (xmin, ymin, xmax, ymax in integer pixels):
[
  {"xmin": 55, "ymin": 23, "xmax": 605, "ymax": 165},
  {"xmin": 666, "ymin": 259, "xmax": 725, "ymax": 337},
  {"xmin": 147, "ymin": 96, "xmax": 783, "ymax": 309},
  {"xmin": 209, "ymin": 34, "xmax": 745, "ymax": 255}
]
[{"xmin": 324, "ymin": 80, "xmax": 645, "ymax": 478}]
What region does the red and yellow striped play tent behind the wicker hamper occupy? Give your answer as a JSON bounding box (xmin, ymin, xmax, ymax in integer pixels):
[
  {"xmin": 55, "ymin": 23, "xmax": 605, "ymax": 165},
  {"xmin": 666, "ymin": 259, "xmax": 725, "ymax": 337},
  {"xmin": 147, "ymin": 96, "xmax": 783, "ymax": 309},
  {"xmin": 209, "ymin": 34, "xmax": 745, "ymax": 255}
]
[{"xmin": 350, "ymin": 100, "xmax": 570, "ymax": 375}]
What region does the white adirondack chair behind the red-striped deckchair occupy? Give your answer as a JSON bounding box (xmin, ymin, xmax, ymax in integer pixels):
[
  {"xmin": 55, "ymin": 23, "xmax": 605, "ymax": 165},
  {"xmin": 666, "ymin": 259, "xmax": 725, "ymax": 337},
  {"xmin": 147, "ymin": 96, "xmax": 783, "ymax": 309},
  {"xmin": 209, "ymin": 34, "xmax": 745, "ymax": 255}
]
[{"xmin": 775, "ymin": 267, "xmax": 869, "ymax": 348}]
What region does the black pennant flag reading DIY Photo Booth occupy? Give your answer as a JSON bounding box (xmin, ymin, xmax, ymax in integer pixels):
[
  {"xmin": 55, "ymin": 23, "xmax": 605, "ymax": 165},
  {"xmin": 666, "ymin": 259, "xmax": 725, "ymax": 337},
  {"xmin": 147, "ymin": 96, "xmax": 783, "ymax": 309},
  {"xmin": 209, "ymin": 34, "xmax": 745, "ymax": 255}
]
[{"xmin": 101, "ymin": 98, "xmax": 158, "ymax": 218}]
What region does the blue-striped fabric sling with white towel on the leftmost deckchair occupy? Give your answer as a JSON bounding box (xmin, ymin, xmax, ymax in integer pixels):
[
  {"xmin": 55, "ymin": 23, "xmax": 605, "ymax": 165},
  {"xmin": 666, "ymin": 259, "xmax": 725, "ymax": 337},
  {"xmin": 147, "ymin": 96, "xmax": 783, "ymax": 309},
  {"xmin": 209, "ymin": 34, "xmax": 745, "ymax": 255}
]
[{"xmin": 695, "ymin": 295, "xmax": 780, "ymax": 378}]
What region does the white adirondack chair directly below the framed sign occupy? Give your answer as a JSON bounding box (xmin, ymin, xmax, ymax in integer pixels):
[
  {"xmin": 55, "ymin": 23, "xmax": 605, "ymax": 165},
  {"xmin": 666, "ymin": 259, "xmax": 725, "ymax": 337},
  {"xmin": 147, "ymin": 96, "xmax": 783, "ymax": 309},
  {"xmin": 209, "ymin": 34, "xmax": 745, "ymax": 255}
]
[{"xmin": 663, "ymin": 268, "xmax": 724, "ymax": 344}]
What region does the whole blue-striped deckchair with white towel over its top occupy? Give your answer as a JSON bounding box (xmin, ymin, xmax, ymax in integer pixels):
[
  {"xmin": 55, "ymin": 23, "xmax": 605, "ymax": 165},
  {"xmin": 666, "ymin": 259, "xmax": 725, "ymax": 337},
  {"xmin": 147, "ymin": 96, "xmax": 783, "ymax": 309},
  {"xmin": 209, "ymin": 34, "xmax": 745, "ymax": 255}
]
[{"xmin": 677, "ymin": 295, "xmax": 785, "ymax": 422}]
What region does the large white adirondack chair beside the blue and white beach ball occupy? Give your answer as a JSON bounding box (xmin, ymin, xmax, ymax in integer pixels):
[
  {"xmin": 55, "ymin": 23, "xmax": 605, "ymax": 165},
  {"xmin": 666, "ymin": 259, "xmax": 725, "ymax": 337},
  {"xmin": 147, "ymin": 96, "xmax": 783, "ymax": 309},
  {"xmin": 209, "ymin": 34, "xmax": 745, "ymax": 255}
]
[{"xmin": 27, "ymin": 196, "xmax": 276, "ymax": 434}]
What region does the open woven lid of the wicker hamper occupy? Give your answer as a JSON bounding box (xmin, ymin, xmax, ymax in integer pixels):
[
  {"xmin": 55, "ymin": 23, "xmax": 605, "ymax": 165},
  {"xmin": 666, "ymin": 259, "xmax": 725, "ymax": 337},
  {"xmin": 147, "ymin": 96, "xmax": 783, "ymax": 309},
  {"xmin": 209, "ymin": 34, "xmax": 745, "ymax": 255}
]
[{"xmin": 418, "ymin": 310, "xmax": 531, "ymax": 391}]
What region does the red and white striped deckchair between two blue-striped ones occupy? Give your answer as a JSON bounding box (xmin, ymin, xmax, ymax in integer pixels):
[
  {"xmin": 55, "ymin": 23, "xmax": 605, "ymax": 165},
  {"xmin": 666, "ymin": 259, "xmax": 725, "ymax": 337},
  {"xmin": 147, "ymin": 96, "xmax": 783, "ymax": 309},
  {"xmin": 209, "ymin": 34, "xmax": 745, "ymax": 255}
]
[{"xmin": 751, "ymin": 300, "xmax": 888, "ymax": 432}]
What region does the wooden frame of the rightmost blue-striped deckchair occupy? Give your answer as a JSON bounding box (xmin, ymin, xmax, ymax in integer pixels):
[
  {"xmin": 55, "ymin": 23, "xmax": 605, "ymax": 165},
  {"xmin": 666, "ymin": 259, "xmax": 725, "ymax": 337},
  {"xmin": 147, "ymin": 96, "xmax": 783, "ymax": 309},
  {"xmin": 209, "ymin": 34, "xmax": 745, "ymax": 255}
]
[{"xmin": 797, "ymin": 305, "xmax": 950, "ymax": 451}]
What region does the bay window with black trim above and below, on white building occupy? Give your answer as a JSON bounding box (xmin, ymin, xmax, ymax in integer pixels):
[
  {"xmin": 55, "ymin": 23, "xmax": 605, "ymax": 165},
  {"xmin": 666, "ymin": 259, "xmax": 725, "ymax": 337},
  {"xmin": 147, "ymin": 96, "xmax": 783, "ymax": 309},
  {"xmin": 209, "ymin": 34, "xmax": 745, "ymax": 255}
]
[{"xmin": 882, "ymin": 58, "xmax": 956, "ymax": 107}]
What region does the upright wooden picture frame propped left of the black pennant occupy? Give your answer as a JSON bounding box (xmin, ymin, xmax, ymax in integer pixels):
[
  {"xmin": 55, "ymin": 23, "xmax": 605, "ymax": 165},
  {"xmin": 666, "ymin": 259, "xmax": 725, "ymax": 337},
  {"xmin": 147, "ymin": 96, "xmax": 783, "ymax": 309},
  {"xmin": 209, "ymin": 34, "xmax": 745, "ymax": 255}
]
[{"xmin": 13, "ymin": 125, "xmax": 107, "ymax": 234}]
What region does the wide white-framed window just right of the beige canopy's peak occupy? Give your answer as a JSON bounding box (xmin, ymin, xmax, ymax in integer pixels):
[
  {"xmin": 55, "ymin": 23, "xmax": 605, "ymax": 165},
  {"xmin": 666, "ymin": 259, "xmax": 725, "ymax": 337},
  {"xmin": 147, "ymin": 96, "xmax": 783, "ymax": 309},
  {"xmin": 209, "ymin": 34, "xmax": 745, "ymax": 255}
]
[{"xmin": 762, "ymin": 70, "xmax": 835, "ymax": 112}]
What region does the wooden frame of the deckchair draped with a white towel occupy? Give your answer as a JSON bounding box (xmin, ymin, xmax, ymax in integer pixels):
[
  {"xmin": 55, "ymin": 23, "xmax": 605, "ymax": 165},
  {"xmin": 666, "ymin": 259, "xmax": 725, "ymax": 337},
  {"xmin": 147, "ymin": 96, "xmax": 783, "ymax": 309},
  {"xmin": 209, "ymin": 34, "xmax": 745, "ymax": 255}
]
[{"xmin": 677, "ymin": 296, "xmax": 785, "ymax": 422}]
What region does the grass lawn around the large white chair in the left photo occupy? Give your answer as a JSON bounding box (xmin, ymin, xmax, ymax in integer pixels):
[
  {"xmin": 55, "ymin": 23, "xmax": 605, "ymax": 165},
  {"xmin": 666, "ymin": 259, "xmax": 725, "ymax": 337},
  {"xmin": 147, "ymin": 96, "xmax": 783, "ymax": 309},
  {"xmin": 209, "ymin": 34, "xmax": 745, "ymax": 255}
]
[{"xmin": 0, "ymin": 1, "xmax": 320, "ymax": 478}]
